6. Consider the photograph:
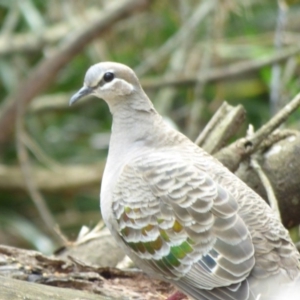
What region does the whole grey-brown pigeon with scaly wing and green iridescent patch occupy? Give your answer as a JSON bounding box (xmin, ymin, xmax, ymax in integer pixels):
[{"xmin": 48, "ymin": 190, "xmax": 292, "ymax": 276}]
[{"xmin": 69, "ymin": 62, "xmax": 300, "ymax": 300}]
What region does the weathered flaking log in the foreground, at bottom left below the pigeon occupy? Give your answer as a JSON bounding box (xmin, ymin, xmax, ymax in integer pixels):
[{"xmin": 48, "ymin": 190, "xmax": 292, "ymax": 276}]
[{"xmin": 0, "ymin": 246, "xmax": 173, "ymax": 300}]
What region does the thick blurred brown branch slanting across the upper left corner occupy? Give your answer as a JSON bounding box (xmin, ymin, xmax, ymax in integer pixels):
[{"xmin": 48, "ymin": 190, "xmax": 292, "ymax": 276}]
[{"xmin": 0, "ymin": 0, "xmax": 149, "ymax": 144}]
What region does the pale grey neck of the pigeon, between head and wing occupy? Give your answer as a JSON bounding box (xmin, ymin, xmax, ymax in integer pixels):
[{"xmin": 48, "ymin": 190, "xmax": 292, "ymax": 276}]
[{"xmin": 109, "ymin": 94, "xmax": 186, "ymax": 164}]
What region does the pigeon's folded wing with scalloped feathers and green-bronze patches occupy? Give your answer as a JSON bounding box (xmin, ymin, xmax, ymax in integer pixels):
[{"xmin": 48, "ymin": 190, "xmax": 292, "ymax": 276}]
[{"xmin": 112, "ymin": 151, "xmax": 254, "ymax": 299}]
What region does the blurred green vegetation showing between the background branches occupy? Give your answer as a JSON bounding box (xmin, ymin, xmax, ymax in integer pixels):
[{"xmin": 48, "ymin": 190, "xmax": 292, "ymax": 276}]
[{"xmin": 0, "ymin": 0, "xmax": 300, "ymax": 252}]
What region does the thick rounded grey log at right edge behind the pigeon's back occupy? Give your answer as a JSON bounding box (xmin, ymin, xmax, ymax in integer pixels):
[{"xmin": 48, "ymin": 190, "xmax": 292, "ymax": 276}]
[{"xmin": 235, "ymin": 130, "xmax": 300, "ymax": 228}]
